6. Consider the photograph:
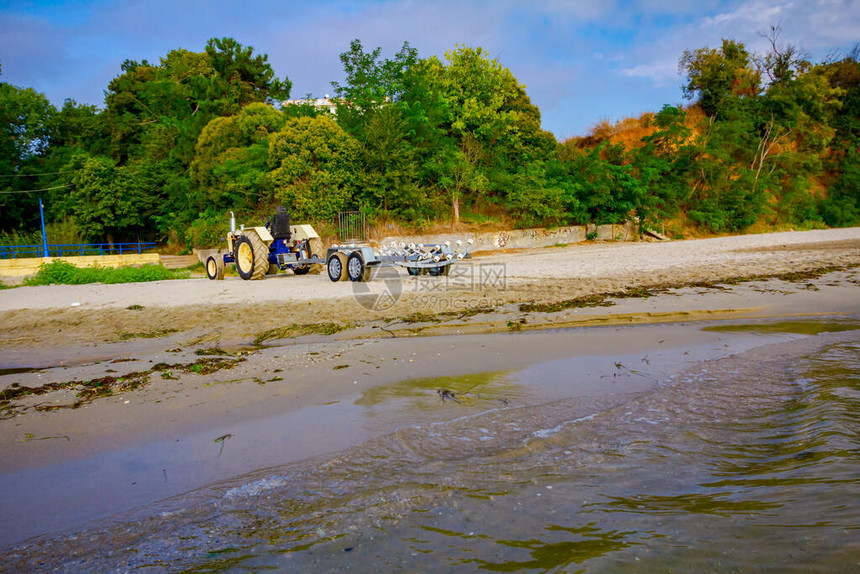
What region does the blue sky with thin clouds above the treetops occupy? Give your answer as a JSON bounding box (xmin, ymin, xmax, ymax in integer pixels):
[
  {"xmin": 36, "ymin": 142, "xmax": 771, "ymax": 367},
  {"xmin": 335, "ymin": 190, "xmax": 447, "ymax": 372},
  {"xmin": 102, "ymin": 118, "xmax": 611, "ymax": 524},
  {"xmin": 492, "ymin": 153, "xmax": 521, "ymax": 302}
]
[{"xmin": 0, "ymin": 0, "xmax": 860, "ymax": 140}]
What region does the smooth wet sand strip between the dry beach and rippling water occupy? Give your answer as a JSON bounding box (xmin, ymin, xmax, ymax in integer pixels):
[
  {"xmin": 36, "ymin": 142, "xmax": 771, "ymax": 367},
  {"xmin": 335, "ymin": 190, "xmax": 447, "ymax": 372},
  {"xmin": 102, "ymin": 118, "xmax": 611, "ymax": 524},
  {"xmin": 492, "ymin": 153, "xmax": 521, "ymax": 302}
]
[{"xmin": 0, "ymin": 314, "xmax": 860, "ymax": 551}]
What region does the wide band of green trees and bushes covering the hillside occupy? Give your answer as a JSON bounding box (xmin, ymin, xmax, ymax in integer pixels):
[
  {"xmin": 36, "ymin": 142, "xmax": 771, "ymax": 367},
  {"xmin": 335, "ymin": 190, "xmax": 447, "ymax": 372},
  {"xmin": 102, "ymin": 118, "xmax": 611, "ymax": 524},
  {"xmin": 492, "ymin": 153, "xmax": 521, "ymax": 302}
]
[{"xmin": 0, "ymin": 30, "xmax": 860, "ymax": 250}]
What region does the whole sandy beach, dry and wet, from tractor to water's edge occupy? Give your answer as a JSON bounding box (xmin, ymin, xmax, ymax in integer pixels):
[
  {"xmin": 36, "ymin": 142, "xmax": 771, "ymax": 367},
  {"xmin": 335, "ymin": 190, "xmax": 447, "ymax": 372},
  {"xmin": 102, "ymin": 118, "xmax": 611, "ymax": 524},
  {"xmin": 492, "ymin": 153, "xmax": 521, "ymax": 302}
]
[{"xmin": 0, "ymin": 228, "xmax": 860, "ymax": 560}]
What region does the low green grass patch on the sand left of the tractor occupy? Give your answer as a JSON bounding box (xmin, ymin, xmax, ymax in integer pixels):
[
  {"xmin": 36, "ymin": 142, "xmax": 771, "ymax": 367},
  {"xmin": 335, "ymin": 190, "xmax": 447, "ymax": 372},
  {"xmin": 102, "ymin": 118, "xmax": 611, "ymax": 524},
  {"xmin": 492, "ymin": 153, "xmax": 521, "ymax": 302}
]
[{"xmin": 24, "ymin": 259, "xmax": 190, "ymax": 286}]
